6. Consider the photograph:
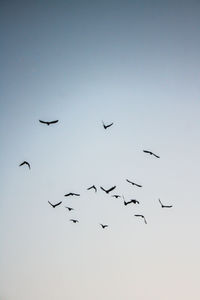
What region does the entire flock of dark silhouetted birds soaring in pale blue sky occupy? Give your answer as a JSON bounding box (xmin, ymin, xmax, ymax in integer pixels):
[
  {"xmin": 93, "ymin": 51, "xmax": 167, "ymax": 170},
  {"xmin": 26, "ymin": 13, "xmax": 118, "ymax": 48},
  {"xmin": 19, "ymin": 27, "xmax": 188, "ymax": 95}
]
[{"xmin": 19, "ymin": 120, "xmax": 173, "ymax": 229}]
